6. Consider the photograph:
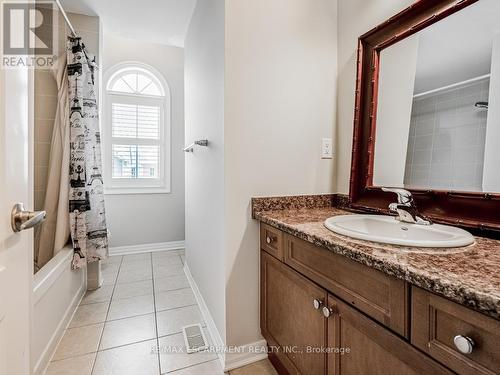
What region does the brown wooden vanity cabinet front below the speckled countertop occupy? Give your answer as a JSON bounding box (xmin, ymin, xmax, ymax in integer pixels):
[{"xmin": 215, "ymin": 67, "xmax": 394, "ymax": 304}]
[{"xmin": 261, "ymin": 228, "xmax": 500, "ymax": 375}]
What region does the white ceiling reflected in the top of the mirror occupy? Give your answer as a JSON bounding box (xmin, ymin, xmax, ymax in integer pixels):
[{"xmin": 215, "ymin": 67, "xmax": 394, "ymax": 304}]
[{"xmin": 412, "ymin": 0, "xmax": 500, "ymax": 93}]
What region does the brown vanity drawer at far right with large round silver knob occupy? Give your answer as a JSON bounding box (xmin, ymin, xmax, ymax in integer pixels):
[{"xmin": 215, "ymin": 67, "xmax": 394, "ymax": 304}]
[{"xmin": 411, "ymin": 287, "xmax": 500, "ymax": 374}]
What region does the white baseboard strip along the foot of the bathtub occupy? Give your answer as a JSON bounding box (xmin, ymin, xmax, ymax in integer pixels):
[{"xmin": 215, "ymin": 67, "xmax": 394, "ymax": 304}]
[{"xmin": 33, "ymin": 275, "xmax": 87, "ymax": 375}]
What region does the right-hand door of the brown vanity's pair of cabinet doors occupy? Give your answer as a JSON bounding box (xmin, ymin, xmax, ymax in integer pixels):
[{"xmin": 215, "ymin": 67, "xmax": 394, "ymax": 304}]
[{"xmin": 328, "ymin": 296, "xmax": 452, "ymax": 375}]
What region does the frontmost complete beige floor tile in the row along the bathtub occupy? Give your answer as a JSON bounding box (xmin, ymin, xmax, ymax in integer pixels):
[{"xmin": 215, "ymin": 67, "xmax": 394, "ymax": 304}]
[{"xmin": 53, "ymin": 324, "xmax": 104, "ymax": 361}]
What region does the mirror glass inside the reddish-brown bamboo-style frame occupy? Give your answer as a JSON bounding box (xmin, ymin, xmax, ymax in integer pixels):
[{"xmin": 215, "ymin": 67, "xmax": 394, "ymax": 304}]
[{"xmin": 373, "ymin": 0, "xmax": 500, "ymax": 192}]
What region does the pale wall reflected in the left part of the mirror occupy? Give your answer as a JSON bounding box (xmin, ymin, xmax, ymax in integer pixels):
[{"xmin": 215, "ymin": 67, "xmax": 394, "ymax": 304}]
[{"xmin": 373, "ymin": 35, "xmax": 419, "ymax": 186}]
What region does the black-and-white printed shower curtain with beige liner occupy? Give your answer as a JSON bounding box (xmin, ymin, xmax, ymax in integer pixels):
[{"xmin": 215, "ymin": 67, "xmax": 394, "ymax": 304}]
[{"xmin": 36, "ymin": 37, "xmax": 108, "ymax": 269}]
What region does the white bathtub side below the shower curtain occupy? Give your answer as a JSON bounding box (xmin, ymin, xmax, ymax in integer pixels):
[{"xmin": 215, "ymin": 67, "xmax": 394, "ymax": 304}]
[{"xmin": 31, "ymin": 247, "xmax": 87, "ymax": 375}]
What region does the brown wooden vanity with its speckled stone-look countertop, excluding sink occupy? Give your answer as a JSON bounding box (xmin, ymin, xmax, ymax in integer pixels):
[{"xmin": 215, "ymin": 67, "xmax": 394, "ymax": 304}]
[{"xmin": 254, "ymin": 197, "xmax": 500, "ymax": 375}]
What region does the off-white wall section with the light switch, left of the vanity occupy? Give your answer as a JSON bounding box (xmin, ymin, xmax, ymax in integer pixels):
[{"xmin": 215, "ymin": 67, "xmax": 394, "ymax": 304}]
[{"xmin": 225, "ymin": 0, "xmax": 337, "ymax": 345}]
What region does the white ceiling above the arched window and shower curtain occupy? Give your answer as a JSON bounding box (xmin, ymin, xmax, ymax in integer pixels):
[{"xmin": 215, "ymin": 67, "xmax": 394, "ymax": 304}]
[{"xmin": 61, "ymin": 0, "xmax": 196, "ymax": 47}]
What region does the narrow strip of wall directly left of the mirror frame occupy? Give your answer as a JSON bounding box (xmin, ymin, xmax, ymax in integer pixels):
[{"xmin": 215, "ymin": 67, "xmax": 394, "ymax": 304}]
[{"xmin": 335, "ymin": 0, "xmax": 414, "ymax": 194}]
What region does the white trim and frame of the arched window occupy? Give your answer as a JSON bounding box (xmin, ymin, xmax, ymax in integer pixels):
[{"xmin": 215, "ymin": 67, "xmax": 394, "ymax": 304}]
[{"xmin": 102, "ymin": 61, "xmax": 171, "ymax": 194}]
